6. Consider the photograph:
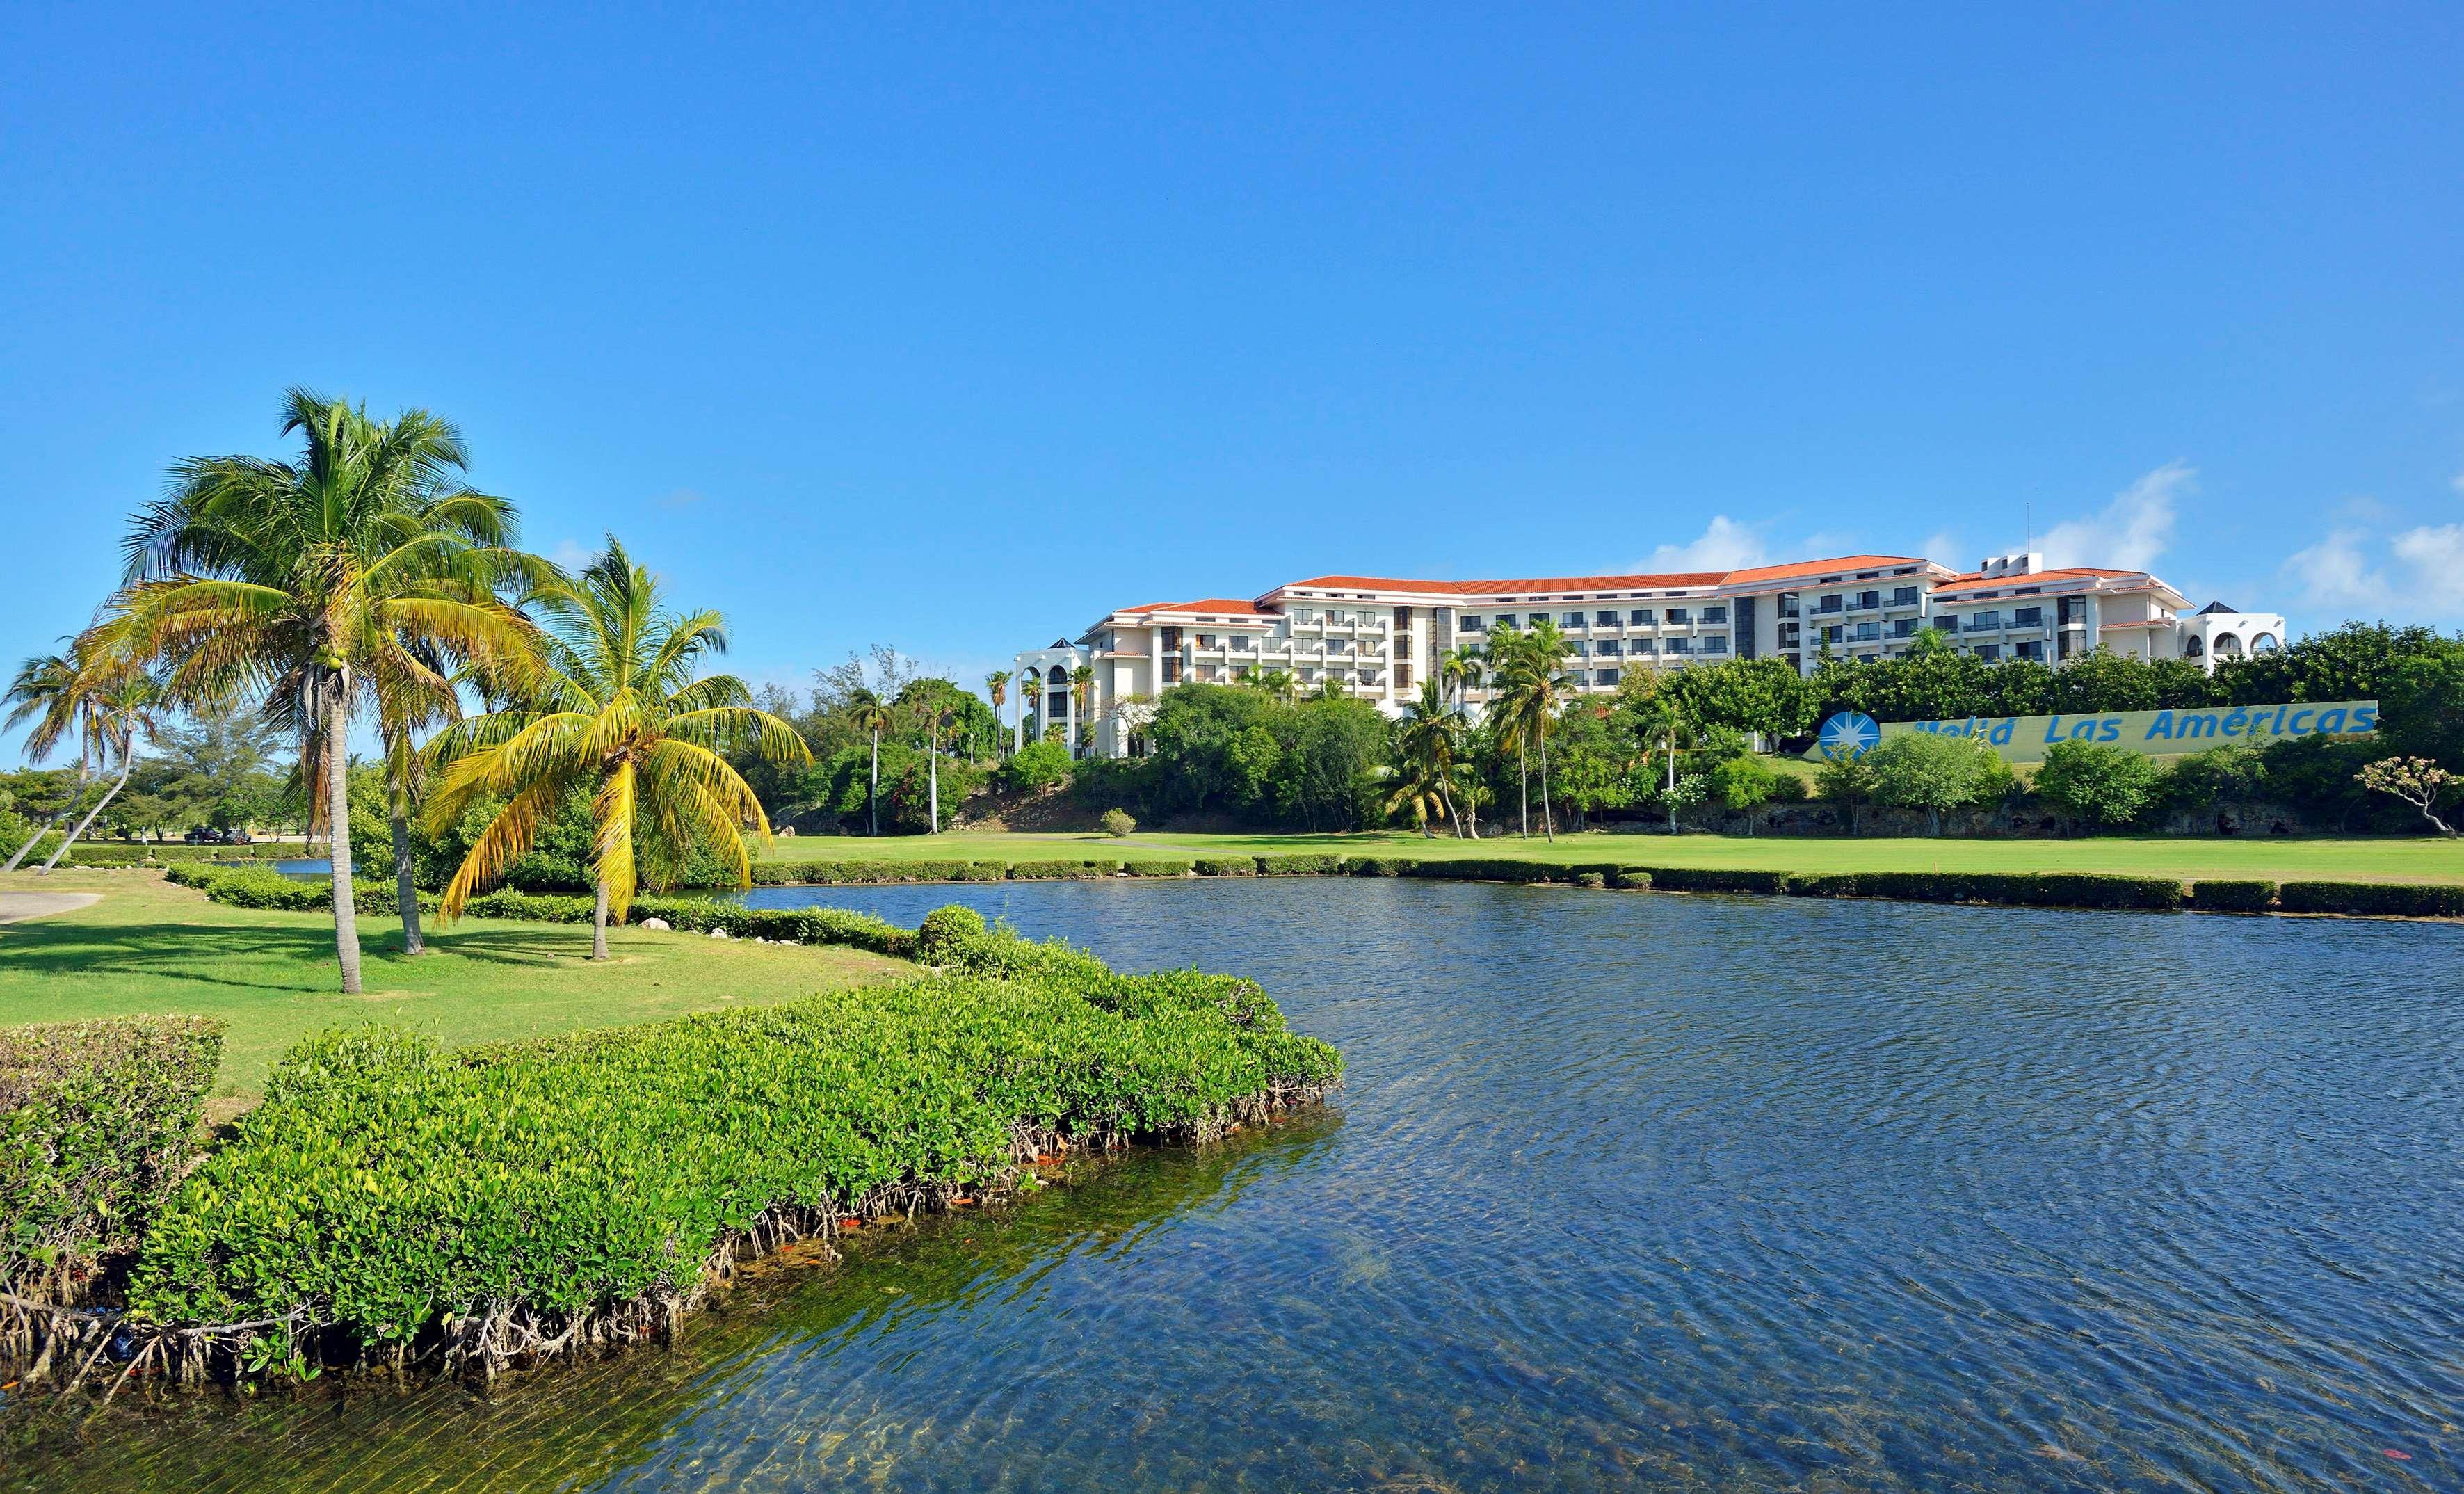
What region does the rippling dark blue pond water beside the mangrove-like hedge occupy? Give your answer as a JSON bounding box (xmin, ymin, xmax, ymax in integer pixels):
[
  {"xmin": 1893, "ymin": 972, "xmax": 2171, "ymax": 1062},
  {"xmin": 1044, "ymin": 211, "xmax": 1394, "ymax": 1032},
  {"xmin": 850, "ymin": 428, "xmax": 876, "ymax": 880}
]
[{"xmin": 10, "ymin": 880, "xmax": 2464, "ymax": 1489}]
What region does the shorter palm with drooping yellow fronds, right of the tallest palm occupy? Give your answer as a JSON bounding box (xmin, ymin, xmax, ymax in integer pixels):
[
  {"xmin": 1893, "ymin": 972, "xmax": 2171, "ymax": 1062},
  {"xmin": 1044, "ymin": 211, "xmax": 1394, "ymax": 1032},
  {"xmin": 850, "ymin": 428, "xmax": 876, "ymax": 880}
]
[{"xmin": 426, "ymin": 535, "xmax": 813, "ymax": 959}]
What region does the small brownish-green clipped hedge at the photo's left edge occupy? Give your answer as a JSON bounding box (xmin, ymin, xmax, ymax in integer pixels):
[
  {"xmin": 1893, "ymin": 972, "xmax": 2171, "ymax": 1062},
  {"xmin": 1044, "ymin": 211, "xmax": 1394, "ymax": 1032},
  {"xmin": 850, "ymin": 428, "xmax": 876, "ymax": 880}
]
[{"xmin": 0, "ymin": 1015, "xmax": 222, "ymax": 1302}]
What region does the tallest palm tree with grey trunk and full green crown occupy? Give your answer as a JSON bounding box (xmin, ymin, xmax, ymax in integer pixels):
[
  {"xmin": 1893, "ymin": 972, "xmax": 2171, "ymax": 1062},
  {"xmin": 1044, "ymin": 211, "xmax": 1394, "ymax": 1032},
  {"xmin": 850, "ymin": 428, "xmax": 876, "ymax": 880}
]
[{"xmin": 104, "ymin": 389, "xmax": 542, "ymax": 993}]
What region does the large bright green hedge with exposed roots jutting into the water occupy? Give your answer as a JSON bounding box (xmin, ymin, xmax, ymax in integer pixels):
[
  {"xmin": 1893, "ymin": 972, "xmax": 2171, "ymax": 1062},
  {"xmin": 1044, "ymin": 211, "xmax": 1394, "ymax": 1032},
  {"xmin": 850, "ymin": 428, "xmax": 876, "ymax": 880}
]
[{"xmin": 128, "ymin": 932, "xmax": 1343, "ymax": 1368}]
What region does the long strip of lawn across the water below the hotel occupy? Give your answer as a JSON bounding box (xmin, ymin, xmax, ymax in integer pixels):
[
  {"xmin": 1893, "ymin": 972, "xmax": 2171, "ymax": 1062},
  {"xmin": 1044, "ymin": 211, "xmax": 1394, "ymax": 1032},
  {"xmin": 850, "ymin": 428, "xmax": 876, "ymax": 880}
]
[{"xmin": 766, "ymin": 821, "xmax": 2464, "ymax": 883}]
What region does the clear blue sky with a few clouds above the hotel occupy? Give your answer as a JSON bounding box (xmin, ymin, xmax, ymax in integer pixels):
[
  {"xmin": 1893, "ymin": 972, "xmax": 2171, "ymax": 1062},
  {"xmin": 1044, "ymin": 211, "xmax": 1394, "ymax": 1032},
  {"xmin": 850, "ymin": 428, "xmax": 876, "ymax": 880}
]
[{"xmin": 0, "ymin": 3, "xmax": 2464, "ymax": 760}]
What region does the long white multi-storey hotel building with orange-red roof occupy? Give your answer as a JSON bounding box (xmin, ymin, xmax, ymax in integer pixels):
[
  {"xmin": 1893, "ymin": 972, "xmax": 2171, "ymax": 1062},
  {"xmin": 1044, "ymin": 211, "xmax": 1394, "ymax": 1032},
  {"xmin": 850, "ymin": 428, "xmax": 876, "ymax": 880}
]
[{"xmin": 1013, "ymin": 555, "xmax": 2284, "ymax": 757}]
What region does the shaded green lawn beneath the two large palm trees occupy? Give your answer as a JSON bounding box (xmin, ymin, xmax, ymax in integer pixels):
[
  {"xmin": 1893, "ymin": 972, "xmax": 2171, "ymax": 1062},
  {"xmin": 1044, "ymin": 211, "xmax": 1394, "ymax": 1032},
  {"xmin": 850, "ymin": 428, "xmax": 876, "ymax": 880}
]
[{"xmin": 0, "ymin": 870, "xmax": 914, "ymax": 1097}]
